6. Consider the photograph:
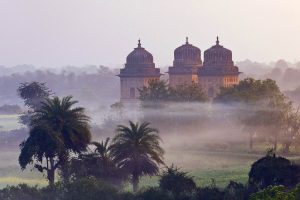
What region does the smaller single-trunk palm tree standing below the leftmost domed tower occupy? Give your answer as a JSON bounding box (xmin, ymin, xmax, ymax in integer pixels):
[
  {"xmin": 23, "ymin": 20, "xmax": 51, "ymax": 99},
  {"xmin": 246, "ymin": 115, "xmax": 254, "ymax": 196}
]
[{"xmin": 111, "ymin": 121, "xmax": 164, "ymax": 192}]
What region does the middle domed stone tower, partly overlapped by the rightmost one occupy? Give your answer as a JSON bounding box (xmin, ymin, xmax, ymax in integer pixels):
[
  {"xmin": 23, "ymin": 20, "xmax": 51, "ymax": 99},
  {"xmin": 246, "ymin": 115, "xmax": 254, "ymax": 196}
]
[{"xmin": 168, "ymin": 38, "xmax": 202, "ymax": 87}]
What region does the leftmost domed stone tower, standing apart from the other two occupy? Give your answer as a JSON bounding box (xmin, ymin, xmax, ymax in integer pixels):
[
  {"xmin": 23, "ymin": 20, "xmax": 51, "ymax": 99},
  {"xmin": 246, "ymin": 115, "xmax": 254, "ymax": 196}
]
[{"xmin": 118, "ymin": 40, "xmax": 161, "ymax": 102}]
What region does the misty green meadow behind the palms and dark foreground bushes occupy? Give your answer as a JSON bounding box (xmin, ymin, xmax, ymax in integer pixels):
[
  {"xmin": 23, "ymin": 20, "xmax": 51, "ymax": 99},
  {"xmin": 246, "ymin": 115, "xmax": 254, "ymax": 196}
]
[{"xmin": 0, "ymin": 112, "xmax": 299, "ymax": 189}]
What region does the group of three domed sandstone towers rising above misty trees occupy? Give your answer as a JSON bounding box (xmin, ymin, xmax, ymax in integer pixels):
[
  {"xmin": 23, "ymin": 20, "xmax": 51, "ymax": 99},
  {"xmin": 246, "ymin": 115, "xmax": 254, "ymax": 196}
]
[{"xmin": 118, "ymin": 37, "xmax": 240, "ymax": 102}]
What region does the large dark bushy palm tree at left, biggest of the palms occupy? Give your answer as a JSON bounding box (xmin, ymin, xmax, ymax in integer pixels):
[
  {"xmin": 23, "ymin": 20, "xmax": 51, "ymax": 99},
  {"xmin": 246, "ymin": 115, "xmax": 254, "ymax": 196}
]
[{"xmin": 19, "ymin": 96, "xmax": 91, "ymax": 184}]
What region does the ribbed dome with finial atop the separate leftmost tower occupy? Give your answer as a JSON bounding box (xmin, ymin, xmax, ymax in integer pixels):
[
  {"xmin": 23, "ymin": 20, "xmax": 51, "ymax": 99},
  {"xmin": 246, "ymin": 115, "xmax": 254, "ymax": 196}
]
[{"xmin": 125, "ymin": 40, "xmax": 155, "ymax": 67}]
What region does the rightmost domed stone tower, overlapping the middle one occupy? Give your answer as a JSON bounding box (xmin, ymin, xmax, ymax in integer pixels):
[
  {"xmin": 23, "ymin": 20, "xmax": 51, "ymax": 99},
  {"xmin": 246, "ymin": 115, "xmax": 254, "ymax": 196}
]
[{"xmin": 198, "ymin": 37, "xmax": 240, "ymax": 98}]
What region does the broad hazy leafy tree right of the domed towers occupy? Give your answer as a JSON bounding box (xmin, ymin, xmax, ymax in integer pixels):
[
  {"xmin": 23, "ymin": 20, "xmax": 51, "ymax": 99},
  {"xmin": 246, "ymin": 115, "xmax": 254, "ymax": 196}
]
[{"xmin": 215, "ymin": 78, "xmax": 292, "ymax": 150}]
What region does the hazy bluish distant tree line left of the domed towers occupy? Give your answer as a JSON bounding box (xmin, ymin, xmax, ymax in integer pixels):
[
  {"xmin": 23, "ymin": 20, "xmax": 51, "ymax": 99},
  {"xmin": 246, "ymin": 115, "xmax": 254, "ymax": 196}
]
[{"xmin": 0, "ymin": 66, "xmax": 119, "ymax": 107}]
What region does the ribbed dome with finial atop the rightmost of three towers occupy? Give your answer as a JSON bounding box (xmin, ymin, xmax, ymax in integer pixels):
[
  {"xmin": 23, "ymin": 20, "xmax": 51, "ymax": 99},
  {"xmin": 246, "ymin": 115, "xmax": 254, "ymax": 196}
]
[{"xmin": 203, "ymin": 37, "xmax": 233, "ymax": 67}]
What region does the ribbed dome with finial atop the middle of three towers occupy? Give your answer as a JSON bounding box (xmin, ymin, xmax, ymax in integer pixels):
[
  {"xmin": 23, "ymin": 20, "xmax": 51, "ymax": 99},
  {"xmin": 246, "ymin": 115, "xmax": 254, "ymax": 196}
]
[{"xmin": 173, "ymin": 38, "xmax": 202, "ymax": 67}]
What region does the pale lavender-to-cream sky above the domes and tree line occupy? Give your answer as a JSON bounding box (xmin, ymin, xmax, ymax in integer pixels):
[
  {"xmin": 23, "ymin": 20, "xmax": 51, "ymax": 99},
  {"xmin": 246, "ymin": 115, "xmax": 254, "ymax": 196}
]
[{"xmin": 0, "ymin": 0, "xmax": 300, "ymax": 67}]
